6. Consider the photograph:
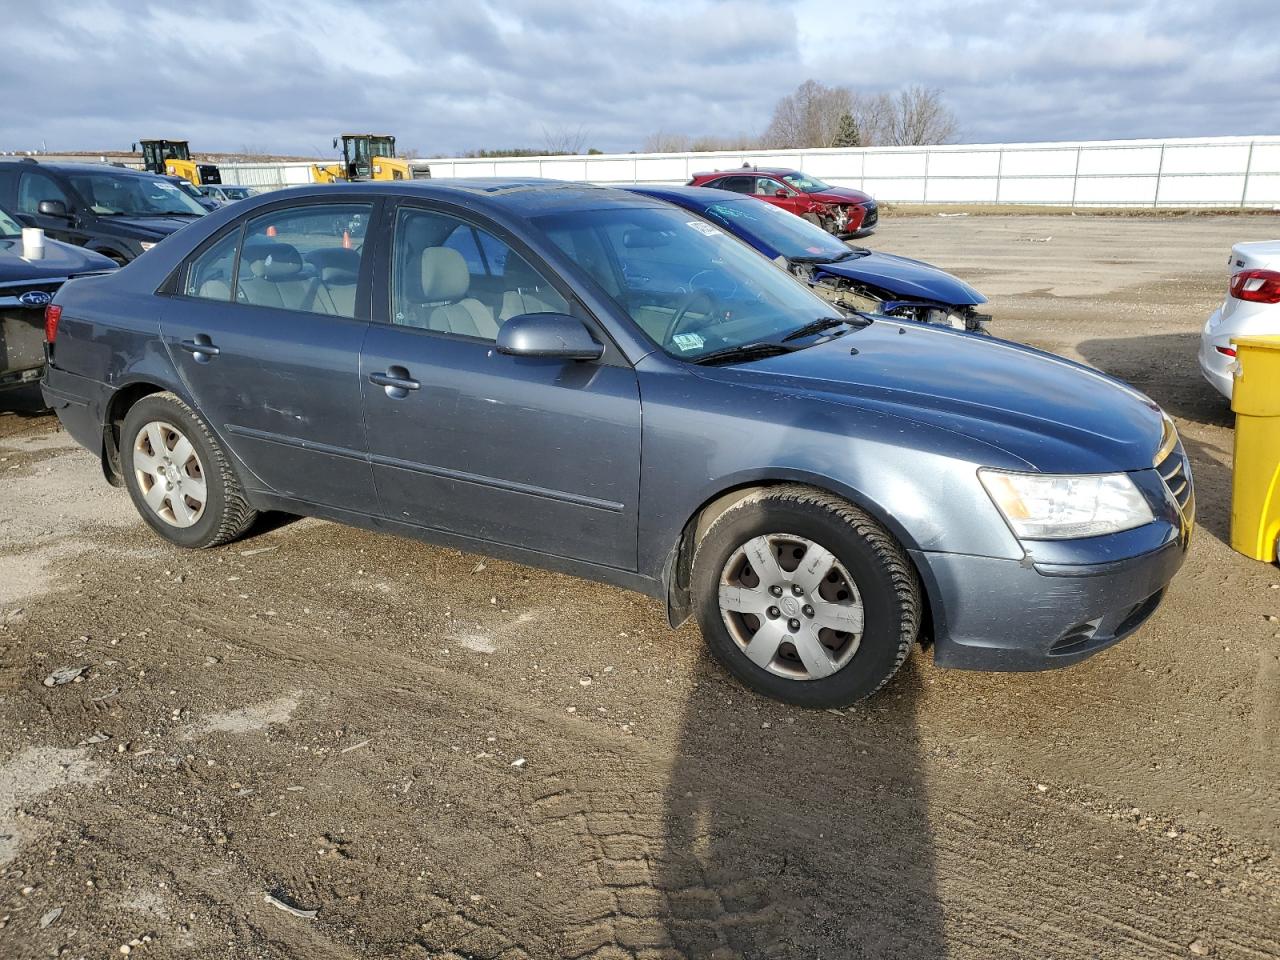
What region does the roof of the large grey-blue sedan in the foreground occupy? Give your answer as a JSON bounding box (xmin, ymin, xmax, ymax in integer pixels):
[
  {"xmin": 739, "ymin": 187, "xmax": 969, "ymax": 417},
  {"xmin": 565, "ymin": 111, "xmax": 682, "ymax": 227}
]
[{"xmin": 236, "ymin": 177, "xmax": 670, "ymax": 218}]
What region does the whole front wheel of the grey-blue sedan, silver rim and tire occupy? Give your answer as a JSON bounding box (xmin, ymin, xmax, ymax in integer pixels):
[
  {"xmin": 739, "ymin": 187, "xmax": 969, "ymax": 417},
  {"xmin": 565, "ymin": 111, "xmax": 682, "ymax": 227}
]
[{"xmin": 692, "ymin": 485, "xmax": 922, "ymax": 707}]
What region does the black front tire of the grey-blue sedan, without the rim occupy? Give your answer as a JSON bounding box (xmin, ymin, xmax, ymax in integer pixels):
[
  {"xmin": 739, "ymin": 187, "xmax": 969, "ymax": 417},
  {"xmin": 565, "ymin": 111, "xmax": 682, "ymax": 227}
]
[{"xmin": 691, "ymin": 484, "xmax": 923, "ymax": 708}]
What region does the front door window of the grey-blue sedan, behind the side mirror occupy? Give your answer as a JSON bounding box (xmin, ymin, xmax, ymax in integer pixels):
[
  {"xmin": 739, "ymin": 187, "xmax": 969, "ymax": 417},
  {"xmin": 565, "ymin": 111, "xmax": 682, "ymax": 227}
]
[{"xmin": 392, "ymin": 209, "xmax": 570, "ymax": 340}]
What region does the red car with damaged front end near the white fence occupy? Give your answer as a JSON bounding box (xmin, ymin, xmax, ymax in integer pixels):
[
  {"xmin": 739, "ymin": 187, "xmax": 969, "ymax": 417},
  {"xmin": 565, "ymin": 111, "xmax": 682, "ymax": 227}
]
[{"xmin": 686, "ymin": 166, "xmax": 879, "ymax": 239}]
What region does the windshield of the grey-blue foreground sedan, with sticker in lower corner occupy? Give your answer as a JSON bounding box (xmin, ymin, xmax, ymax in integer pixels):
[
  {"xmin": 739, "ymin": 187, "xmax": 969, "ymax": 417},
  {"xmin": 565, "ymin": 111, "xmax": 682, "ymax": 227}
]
[{"xmin": 534, "ymin": 206, "xmax": 833, "ymax": 360}]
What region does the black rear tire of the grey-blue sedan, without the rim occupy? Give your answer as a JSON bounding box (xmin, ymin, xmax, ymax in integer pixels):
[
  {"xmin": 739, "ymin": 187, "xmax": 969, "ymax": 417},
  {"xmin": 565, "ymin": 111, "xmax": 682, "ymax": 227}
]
[{"xmin": 120, "ymin": 393, "xmax": 257, "ymax": 549}]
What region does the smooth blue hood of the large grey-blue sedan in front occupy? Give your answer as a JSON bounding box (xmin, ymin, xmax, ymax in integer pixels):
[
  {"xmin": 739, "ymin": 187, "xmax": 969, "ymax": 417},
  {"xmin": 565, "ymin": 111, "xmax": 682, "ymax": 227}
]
[{"xmin": 695, "ymin": 320, "xmax": 1164, "ymax": 474}]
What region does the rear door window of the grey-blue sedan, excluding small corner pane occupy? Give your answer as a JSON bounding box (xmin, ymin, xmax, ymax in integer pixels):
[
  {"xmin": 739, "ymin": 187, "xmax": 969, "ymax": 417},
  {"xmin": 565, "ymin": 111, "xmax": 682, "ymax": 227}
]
[{"xmin": 236, "ymin": 204, "xmax": 372, "ymax": 319}]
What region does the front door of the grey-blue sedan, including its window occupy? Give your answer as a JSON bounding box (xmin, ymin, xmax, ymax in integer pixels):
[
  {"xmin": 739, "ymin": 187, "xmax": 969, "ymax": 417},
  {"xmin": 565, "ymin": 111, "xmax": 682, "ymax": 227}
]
[{"xmin": 361, "ymin": 200, "xmax": 640, "ymax": 570}]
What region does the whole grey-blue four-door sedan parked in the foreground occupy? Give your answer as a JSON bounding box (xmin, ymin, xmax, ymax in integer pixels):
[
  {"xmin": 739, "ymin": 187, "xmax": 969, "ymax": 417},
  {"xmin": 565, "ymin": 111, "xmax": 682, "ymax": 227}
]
[{"xmin": 44, "ymin": 179, "xmax": 1194, "ymax": 707}]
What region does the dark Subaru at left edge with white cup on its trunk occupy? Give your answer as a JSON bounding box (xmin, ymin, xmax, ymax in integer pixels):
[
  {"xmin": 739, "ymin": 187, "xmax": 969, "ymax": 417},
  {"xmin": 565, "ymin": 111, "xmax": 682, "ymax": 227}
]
[{"xmin": 0, "ymin": 207, "xmax": 115, "ymax": 390}]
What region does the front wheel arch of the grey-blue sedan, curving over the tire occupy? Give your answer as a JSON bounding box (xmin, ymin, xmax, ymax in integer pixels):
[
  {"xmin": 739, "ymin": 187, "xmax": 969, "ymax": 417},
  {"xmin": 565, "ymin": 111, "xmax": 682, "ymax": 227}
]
[{"xmin": 662, "ymin": 470, "xmax": 933, "ymax": 637}]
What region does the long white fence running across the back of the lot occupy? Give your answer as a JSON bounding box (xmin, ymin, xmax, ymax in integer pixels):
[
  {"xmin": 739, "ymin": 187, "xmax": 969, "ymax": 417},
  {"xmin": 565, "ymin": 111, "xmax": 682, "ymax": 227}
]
[{"xmin": 221, "ymin": 137, "xmax": 1280, "ymax": 207}]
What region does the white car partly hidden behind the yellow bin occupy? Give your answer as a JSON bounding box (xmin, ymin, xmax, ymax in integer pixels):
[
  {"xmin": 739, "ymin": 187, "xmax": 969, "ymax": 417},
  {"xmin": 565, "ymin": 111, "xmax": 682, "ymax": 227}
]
[{"xmin": 1199, "ymin": 241, "xmax": 1280, "ymax": 399}]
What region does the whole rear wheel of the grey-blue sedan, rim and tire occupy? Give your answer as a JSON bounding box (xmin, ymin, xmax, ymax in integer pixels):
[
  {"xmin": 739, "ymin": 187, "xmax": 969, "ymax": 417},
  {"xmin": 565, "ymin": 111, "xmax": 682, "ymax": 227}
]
[{"xmin": 120, "ymin": 393, "xmax": 257, "ymax": 548}]
